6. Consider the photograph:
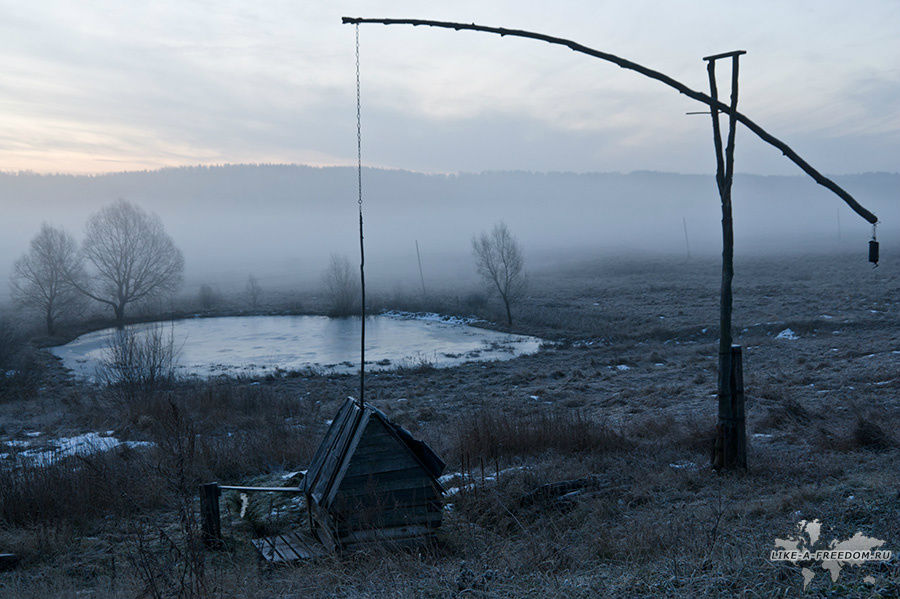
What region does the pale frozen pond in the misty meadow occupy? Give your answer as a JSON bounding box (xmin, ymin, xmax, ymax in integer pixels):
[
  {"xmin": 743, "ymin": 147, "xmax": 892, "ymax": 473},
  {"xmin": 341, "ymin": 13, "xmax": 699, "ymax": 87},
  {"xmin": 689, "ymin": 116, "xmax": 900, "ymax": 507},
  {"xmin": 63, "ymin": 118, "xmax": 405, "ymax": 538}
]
[{"xmin": 51, "ymin": 313, "xmax": 541, "ymax": 379}]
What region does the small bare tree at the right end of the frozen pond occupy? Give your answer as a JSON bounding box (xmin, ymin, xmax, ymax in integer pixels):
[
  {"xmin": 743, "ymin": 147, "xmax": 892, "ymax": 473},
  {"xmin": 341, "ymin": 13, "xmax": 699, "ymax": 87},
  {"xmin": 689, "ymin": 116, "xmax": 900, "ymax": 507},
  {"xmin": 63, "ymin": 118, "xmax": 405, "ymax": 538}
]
[{"xmin": 472, "ymin": 222, "xmax": 526, "ymax": 325}]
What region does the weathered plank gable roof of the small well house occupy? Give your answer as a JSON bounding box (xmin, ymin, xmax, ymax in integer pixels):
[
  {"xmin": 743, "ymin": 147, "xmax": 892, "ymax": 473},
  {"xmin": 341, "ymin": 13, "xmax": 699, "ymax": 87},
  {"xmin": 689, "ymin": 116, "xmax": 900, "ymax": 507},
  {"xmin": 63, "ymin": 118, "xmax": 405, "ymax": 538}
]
[{"xmin": 303, "ymin": 398, "xmax": 445, "ymax": 508}]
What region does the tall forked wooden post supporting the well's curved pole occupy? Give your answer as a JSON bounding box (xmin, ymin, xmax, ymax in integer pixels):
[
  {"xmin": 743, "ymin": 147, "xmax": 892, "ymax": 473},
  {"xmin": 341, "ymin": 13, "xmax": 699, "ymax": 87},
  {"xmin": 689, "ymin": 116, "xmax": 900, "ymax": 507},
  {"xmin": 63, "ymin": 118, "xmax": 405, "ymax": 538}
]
[{"xmin": 704, "ymin": 50, "xmax": 747, "ymax": 468}]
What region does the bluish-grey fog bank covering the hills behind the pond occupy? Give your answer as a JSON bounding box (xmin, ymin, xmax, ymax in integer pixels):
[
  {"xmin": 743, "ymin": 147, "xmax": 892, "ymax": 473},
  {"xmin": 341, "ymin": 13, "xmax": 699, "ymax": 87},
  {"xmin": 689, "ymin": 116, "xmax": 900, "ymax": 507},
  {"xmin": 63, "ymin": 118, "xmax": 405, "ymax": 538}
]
[{"xmin": 0, "ymin": 165, "xmax": 900, "ymax": 299}]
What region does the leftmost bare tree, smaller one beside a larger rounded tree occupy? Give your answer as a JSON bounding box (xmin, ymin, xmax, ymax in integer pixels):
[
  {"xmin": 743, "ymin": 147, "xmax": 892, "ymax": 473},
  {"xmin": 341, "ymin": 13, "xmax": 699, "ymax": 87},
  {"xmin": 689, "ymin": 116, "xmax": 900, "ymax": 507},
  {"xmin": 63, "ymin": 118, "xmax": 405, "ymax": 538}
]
[{"xmin": 10, "ymin": 223, "xmax": 83, "ymax": 335}]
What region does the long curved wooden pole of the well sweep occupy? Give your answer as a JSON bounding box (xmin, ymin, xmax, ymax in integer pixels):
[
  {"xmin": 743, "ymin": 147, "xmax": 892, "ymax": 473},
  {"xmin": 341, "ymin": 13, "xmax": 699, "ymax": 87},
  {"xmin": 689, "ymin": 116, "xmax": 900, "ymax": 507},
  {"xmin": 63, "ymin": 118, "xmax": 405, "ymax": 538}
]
[{"xmin": 341, "ymin": 17, "xmax": 878, "ymax": 224}]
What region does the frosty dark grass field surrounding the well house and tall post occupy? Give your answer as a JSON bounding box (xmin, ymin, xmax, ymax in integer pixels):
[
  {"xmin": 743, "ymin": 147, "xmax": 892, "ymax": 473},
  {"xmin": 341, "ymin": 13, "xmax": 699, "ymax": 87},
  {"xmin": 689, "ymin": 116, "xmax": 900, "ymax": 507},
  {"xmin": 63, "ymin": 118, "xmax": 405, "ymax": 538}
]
[{"xmin": 0, "ymin": 247, "xmax": 900, "ymax": 598}]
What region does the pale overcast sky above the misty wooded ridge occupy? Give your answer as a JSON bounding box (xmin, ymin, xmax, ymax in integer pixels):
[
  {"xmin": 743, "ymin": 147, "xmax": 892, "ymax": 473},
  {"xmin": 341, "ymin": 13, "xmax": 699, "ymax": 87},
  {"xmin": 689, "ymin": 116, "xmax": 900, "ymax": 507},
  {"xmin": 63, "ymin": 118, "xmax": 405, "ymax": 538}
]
[{"xmin": 0, "ymin": 0, "xmax": 900, "ymax": 174}]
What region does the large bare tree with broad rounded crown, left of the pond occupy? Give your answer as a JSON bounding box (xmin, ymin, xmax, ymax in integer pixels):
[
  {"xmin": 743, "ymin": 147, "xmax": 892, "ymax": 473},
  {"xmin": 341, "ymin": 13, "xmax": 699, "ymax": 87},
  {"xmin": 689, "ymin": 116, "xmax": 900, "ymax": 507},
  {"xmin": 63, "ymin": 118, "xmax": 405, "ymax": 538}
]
[{"xmin": 77, "ymin": 200, "xmax": 184, "ymax": 325}]
